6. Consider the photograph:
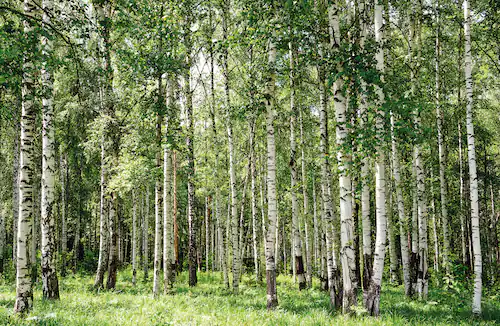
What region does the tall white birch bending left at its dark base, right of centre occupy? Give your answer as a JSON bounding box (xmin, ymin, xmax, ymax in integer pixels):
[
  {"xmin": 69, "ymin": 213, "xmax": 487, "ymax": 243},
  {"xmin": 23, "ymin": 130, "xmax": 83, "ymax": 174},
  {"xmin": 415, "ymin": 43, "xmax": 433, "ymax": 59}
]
[{"xmin": 363, "ymin": 2, "xmax": 387, "ymax": 316}]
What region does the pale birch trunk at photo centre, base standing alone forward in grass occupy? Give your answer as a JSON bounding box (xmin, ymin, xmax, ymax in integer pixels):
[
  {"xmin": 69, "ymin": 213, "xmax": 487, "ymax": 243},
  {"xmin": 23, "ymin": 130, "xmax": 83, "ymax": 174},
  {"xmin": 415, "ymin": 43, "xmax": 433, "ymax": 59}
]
[{"xmin": 264, "ymin": 40, "xmax": 278, "ymax": 310}]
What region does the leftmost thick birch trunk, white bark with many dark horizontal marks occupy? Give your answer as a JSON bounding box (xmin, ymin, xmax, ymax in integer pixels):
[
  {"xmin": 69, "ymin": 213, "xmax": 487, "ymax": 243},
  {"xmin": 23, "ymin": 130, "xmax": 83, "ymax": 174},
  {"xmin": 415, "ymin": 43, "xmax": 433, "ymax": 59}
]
[{"xmin": 14, "ymin": 0, "xmax": 36, "ymax": 314}]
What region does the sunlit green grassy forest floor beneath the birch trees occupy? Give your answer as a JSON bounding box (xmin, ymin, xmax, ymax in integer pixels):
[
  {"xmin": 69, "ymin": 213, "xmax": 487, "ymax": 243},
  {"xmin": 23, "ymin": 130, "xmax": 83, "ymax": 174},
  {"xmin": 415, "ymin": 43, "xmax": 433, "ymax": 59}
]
[{"xmin": 0, "ymin": 269, "xmax": 500, "ymax": 326}]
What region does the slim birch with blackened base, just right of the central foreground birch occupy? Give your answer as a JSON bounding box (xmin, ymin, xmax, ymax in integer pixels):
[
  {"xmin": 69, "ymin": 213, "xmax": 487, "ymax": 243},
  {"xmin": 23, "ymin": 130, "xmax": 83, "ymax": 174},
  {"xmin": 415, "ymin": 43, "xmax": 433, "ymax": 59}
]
[{"xmin": 288, "ymin": 37, "xmax": 306, "ymax": 290}]
